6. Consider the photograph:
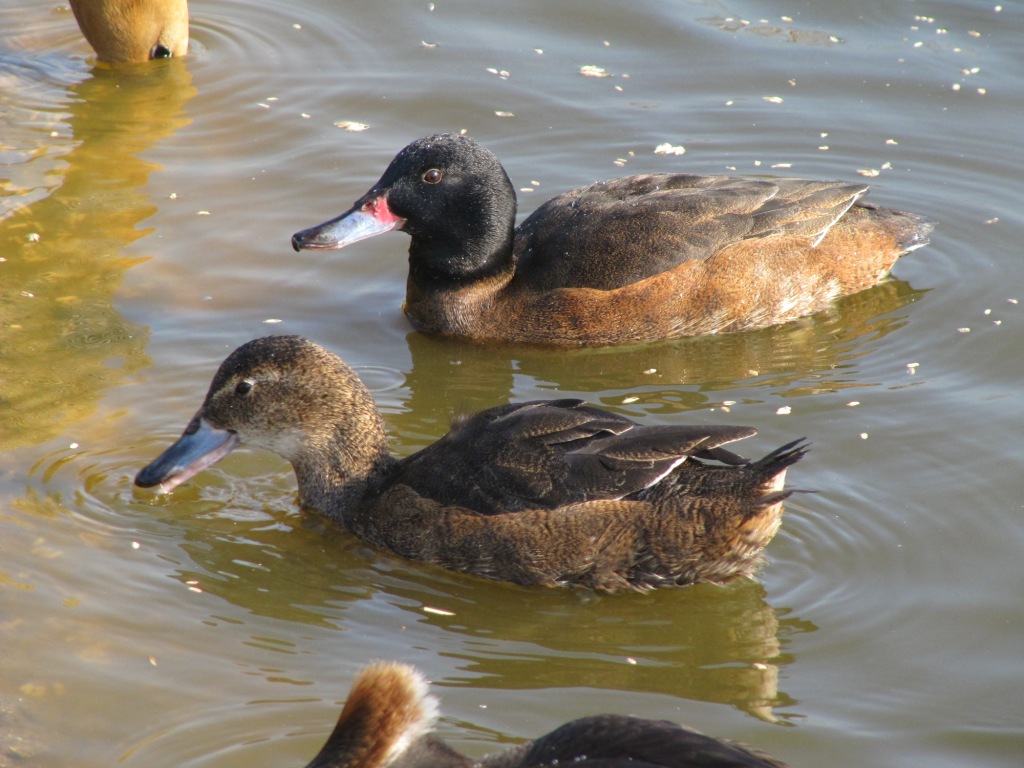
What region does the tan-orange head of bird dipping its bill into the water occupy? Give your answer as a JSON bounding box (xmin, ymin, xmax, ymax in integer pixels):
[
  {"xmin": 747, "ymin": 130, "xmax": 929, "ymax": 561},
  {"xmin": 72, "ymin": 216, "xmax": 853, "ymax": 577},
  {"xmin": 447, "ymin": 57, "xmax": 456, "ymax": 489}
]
[{"xmin": 71, "ymin": 0, "xmax": 188, "ymax": 61}]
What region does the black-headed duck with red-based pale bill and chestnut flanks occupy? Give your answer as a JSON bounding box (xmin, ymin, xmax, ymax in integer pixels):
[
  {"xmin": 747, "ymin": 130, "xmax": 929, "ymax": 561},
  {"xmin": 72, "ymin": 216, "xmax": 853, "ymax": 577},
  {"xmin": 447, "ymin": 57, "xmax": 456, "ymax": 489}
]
[{"xmin": 292, "ymin": 134, "xmax": 932, "ymax": 346}]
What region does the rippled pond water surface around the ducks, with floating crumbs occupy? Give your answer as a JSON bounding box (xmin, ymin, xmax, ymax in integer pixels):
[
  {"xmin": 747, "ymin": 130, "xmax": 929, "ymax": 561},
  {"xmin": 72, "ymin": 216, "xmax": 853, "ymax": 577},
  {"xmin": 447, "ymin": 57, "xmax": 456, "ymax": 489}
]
[{"xmin": 0, "ymin": 0, "xmax": 1024, "ymax": 768}]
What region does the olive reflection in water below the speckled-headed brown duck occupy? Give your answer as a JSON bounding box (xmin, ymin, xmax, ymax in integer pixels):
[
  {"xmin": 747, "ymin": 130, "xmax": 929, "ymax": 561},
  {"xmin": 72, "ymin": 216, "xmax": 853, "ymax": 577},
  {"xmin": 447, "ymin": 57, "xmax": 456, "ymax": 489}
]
[{"xmin": 161, "ymin": 495, "xmax": 816, "ymax": 722}]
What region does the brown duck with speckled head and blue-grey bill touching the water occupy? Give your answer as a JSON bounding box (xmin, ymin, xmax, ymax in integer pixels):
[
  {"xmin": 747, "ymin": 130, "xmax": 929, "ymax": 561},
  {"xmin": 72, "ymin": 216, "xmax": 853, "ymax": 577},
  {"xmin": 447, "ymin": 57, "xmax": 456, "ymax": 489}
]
[{"xmin": 135, "ymin": 336, "xmax": 805, "ymax": 591}]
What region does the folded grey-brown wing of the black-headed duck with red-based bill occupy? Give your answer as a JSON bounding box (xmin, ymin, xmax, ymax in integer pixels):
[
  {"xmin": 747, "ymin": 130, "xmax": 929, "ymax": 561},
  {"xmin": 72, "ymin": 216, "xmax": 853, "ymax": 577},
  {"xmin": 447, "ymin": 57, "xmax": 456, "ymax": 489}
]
[{"xmin": 513, "ymin": 174, "xmax": 867, "ymax": 291}]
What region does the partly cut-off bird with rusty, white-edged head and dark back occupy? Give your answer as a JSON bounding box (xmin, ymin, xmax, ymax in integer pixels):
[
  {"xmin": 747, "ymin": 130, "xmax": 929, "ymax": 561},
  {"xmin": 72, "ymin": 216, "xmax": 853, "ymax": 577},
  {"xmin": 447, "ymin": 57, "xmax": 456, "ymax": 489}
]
[{"xmin": 306, "ymin": 663, "xmax": 785, "ymax": 768}]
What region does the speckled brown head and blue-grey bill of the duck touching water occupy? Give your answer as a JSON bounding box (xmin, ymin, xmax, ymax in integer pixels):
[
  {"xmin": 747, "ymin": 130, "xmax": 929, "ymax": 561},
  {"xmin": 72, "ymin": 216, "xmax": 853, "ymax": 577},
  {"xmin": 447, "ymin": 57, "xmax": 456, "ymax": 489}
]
[{"xmin": 136, "ymin": 336, "xmax": 393, "ymax": 516}]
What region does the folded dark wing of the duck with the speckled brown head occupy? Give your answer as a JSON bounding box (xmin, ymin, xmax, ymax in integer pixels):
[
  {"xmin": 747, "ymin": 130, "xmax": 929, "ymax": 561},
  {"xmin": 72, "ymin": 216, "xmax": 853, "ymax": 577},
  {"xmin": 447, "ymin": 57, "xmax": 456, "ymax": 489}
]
[{"xmin": 388, "ymin": 399, "xmax": 757, "ymax": 514}]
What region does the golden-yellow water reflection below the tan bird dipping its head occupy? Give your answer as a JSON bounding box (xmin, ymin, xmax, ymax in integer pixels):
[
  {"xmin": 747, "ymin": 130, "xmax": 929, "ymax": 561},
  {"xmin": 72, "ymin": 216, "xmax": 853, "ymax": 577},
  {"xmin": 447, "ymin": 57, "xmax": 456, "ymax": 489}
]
[{"xmin": 0, "ymin": 59, "xmax": 196, "ymax": 450}]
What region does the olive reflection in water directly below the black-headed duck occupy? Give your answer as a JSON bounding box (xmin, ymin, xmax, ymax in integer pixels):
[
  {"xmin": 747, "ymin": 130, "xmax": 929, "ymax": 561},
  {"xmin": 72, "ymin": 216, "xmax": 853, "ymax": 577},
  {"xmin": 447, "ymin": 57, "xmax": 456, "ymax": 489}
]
[{"xmin": 389, "ymin": 280, "xmax": 926, "ymax": 441}]
